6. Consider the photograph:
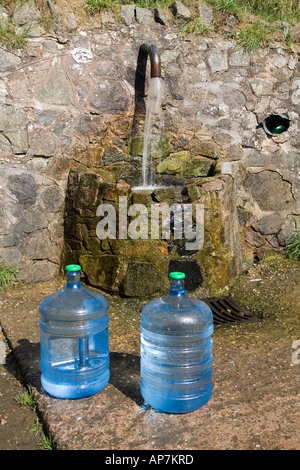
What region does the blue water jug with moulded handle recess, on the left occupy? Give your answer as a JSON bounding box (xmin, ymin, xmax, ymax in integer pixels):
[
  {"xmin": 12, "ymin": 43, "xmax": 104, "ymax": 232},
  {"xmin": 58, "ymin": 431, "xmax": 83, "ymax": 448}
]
[{"xmin": 39, "ymin": 265, "xmax": 110, "ymax": 399}]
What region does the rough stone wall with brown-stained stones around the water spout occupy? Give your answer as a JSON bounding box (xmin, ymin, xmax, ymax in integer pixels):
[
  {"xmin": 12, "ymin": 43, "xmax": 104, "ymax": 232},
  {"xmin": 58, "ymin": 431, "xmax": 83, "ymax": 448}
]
[{"xmin": 0, "ymin": 1, "xmax": 300, "ymax": 290}]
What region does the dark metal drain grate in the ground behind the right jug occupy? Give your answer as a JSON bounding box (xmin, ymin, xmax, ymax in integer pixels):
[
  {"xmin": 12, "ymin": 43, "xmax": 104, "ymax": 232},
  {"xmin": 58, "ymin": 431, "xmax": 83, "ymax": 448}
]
[{"xmin": 203, "ymin": 296, "xmax": 262, "ymax": 326}]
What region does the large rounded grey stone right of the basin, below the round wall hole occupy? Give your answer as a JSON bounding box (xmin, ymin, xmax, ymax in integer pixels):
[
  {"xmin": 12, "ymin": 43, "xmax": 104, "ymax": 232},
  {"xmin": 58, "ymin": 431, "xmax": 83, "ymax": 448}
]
[{"xmin": 245, "ymin": 170, "xmax": 294, "ymax": 211}]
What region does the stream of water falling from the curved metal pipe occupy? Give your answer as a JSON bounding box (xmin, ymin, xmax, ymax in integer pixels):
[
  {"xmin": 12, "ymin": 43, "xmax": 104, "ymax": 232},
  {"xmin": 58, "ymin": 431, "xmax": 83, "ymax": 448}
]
[{"xmin": 140, "ymin": 77, "xmax": 163, "ymax": 189}]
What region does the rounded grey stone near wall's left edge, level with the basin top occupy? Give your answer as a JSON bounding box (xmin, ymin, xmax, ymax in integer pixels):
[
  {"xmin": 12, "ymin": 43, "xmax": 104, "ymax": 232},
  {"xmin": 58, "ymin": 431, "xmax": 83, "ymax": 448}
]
[{"xmin": 8, "ymin": 173, "xmax": 38, "ymax": 208}]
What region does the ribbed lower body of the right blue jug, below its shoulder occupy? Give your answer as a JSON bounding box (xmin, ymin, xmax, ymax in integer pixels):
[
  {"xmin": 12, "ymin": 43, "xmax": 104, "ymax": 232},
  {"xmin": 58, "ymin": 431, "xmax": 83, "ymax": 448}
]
[{"xmin": 141, "ymin": 330, "xmax": 212, "ymax": 413}]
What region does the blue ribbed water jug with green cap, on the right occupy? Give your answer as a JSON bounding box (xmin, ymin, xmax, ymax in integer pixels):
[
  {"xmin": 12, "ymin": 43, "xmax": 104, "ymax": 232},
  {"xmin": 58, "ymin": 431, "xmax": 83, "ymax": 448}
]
[{"xmin": 140, "ymin": 272, "xmax": 214, "ymax": 413}]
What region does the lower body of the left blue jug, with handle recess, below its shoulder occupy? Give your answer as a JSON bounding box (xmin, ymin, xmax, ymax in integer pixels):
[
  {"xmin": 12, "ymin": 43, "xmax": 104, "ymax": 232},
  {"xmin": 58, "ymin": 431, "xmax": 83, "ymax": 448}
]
[{"xmin": 40, "ymin": 315, "xmax": 109, "ymax": 399}]
